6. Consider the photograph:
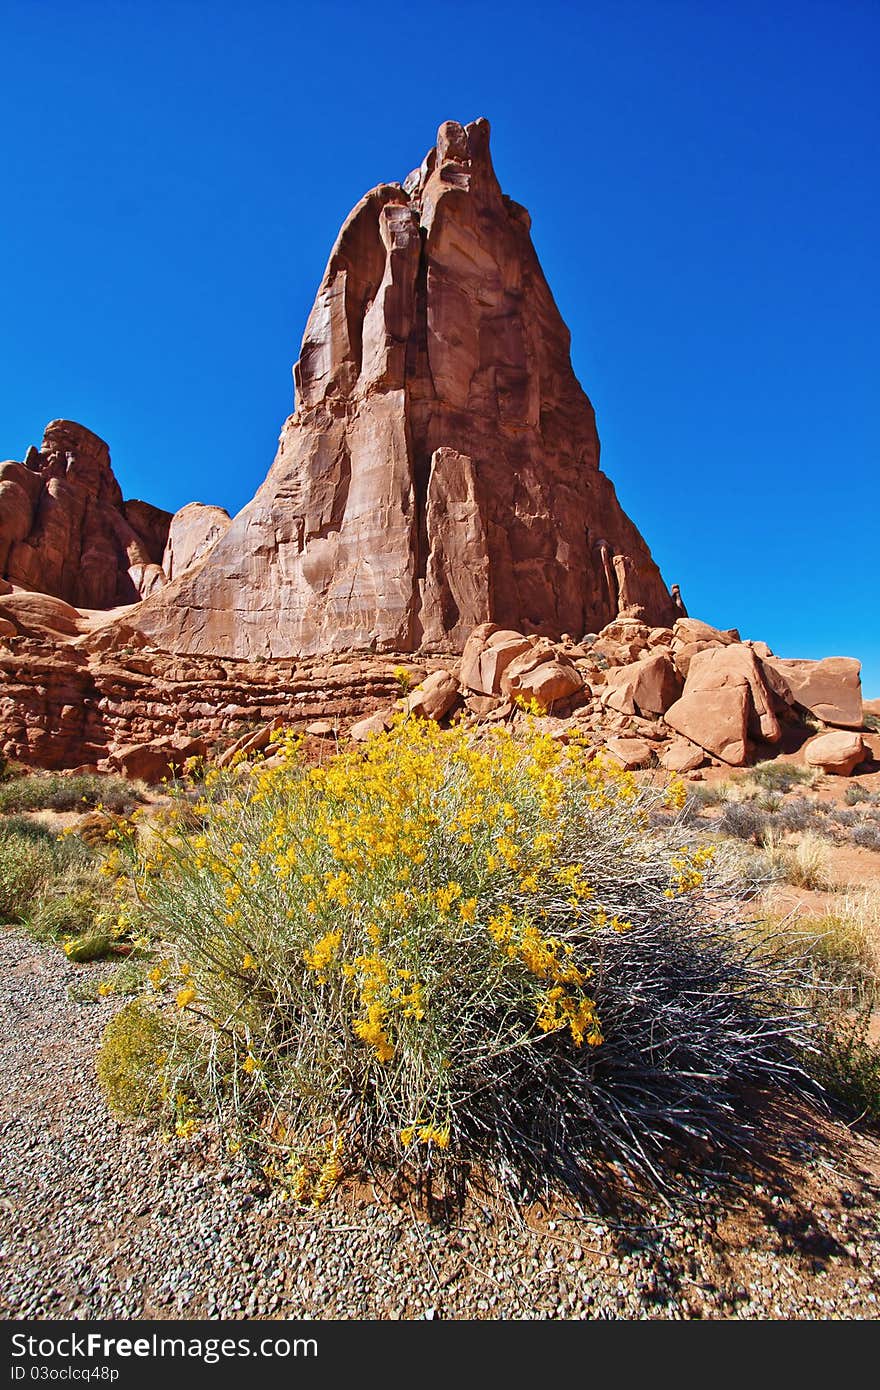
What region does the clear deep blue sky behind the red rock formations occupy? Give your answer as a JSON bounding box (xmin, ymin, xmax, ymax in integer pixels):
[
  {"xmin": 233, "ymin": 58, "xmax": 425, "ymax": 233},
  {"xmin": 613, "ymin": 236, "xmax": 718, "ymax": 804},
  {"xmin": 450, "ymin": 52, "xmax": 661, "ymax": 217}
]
[{"xmin": 0, "ymin": 0, "xmax": 880, "ymax": 696}]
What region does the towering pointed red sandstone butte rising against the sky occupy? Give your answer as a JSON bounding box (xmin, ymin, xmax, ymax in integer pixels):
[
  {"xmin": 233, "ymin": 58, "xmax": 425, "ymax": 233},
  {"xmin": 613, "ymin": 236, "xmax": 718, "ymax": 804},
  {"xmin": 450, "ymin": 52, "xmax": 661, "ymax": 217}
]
[{"xmin": 138, "ymin": 121, "xmax": 677, "ymax": 657}]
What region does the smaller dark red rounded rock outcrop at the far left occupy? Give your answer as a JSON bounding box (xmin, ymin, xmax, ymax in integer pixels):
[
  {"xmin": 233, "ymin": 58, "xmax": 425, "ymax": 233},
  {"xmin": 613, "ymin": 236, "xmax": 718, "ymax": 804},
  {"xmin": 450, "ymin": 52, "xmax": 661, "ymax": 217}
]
[{"xmin": 0, "ymin": 420, "xmax": 171, "ymax": 609}]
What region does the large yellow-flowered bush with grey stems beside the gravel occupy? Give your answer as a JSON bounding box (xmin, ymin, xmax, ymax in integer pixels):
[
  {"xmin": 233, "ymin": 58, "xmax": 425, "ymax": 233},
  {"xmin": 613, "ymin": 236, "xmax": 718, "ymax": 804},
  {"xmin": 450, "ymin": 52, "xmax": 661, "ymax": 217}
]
[{"xmin": 99, "ymin": 719, "xmax": 809, "ymax": 1201}]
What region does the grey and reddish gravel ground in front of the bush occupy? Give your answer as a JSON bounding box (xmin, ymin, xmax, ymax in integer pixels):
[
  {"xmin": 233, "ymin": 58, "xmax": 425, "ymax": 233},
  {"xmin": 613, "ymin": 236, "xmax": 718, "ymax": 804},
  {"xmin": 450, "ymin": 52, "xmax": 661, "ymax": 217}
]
[{"xmin": 0, "ymin": 929, "xmax": 880, "ymax": 1319}]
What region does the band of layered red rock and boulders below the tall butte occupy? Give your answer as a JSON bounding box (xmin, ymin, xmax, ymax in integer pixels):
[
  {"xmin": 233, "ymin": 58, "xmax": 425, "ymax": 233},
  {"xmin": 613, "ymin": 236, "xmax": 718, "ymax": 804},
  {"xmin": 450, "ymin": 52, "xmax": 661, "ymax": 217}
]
[{"xmin": 0, "ymin": 611, "xmax": 880, "ymax": 780}]
